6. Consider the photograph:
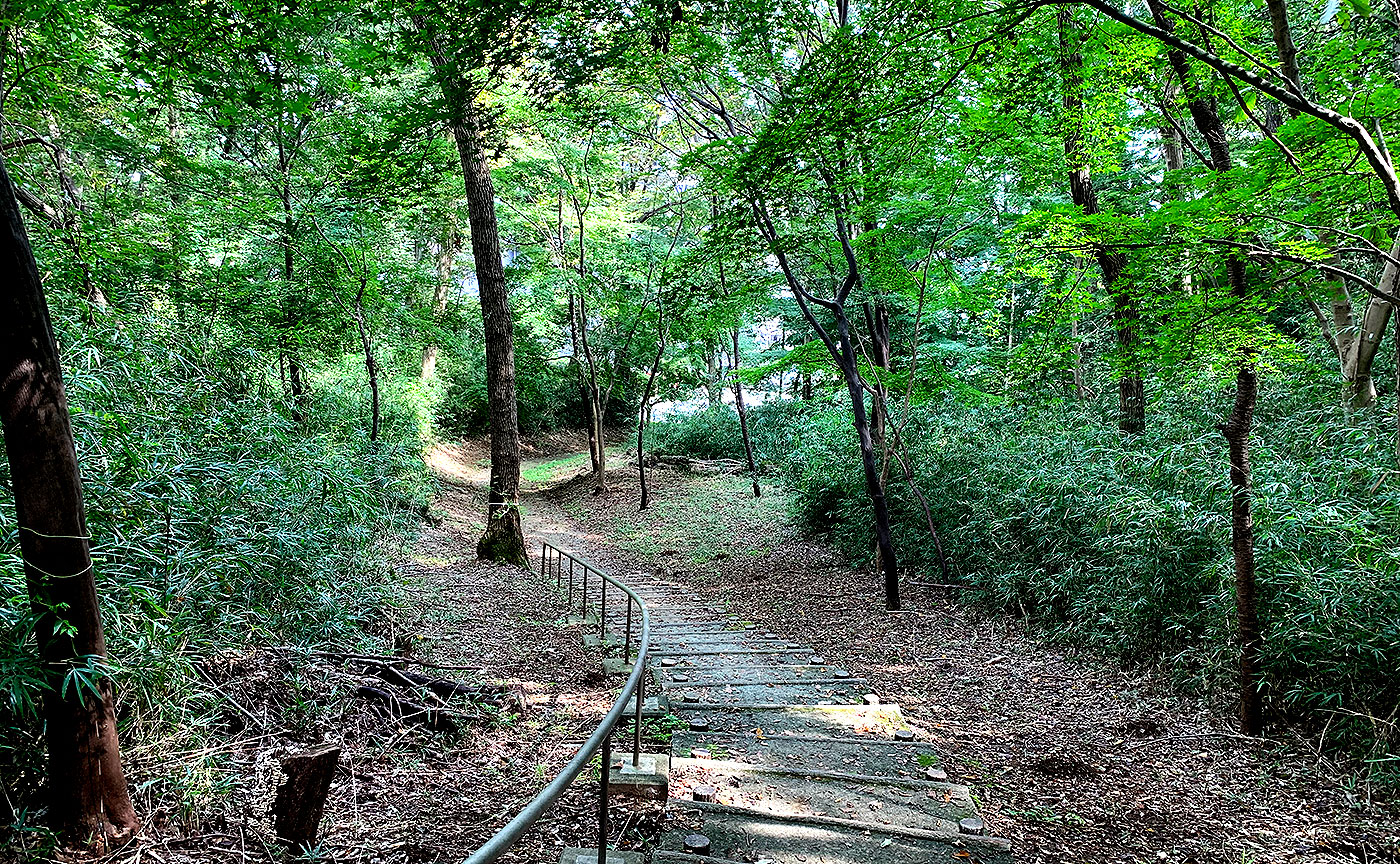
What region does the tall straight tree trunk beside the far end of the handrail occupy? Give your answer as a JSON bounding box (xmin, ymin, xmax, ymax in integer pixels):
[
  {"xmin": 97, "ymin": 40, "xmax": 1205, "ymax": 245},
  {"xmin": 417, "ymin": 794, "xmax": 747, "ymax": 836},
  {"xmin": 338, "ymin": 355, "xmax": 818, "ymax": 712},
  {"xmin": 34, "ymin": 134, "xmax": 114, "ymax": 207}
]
[{"xmin": 414, "ymin": 17, "xmax": 528, "ymax": 564}]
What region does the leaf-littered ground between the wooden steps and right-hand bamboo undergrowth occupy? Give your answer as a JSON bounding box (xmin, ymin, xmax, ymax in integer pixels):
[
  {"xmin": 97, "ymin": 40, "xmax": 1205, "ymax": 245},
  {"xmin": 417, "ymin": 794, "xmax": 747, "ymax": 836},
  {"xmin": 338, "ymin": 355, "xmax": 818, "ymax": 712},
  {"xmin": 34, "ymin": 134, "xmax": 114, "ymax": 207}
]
[{"xmin": 531, "ymin": 462, "xmax": 1400, "ymax": 863}]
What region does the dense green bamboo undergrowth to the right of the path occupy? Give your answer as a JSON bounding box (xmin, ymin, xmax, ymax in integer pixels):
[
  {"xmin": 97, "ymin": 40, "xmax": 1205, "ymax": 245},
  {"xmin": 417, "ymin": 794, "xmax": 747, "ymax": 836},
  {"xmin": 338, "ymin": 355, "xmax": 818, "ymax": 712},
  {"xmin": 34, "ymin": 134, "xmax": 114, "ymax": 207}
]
[{"xmin": 652, "ymin": 381, "xmax": 1400, "ymax": 786}]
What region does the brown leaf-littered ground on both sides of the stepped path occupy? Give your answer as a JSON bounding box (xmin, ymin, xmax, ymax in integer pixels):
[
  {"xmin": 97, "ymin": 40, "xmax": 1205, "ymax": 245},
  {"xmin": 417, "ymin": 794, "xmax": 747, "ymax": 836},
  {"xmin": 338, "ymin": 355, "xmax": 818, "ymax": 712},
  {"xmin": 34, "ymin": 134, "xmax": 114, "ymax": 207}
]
[{"xmin": 113, "ymin": 448, "xmax": 1400, "ymax": 864}]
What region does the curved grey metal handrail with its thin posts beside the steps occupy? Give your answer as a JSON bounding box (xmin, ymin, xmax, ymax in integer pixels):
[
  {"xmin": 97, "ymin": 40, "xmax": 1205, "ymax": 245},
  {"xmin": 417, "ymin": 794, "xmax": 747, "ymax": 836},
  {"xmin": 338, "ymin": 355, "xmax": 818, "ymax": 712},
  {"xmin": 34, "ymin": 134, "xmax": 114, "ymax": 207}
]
[{"xmin": 466, "ymin": 541, "xmax": 651, "ymax": 864}]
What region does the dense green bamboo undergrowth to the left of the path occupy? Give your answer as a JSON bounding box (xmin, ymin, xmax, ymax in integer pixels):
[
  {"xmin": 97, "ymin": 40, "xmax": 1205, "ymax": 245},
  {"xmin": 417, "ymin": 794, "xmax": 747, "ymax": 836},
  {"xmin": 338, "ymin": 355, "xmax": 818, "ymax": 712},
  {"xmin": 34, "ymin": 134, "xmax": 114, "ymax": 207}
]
[{"xmin": 0, "ymin": 303, "xmax": 428, "ymax": 830}]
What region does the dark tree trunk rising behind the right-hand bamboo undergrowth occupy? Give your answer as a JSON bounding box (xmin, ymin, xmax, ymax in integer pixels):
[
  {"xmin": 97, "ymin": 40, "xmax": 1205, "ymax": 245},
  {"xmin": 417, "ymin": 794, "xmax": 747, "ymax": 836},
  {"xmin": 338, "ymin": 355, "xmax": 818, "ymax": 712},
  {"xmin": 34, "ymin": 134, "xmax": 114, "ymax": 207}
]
[{"xmin": 1057, "ymin": 7, "xmax": 1147, "ymax": 434}]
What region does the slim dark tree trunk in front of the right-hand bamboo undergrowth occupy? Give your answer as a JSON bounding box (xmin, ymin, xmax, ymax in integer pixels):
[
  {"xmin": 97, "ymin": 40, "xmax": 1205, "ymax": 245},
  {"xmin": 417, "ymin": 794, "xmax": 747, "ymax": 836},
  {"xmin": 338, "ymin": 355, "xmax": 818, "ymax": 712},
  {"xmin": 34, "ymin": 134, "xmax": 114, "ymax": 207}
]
[{"xmin": 1148, "ymin": 0, "xmax": 1263, "ymax": 735}]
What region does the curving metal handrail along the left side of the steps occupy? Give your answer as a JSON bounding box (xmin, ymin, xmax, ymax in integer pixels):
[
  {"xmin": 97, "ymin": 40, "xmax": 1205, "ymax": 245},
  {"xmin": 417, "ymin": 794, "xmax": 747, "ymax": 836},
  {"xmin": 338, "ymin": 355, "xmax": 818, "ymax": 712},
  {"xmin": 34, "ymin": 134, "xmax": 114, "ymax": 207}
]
[{"xmin": 466, "ymin": 542, "xmax": 651, "ymax": 864}]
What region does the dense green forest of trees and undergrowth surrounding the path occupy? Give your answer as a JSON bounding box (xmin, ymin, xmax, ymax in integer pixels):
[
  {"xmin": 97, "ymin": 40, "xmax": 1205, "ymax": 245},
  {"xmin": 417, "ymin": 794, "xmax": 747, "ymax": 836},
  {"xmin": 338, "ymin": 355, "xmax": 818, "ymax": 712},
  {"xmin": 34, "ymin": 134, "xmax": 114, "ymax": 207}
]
[{"xmin": 0, "ymin": 0, "xmax": 1400, "ymax": 864}]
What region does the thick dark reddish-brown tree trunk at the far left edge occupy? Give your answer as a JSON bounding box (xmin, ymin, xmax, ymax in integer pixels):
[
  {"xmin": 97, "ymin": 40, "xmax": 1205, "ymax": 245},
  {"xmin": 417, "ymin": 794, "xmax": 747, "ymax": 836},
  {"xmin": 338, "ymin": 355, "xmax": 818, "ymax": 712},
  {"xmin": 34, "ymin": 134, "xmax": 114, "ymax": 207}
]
[{"xmin": 0, "ymin": 154, "xmax": 140, "ymax": 847}]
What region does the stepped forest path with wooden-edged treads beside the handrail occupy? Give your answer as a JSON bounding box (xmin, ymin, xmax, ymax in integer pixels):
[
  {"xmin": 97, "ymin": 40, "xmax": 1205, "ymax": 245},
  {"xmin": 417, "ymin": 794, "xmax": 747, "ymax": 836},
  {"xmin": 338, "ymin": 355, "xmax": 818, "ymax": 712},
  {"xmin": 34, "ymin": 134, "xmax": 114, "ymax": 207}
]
[{"xmin": 450, "ymin": 450, "xmax": 1011, "ymax": 864}]
